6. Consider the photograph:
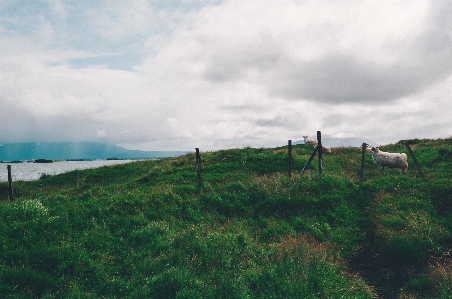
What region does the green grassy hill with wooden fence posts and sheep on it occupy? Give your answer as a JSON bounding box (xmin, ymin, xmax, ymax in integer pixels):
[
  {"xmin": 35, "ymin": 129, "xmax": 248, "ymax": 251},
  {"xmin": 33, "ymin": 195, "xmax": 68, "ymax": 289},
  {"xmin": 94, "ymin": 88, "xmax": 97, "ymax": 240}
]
[{"xmin": 0, "ymin": 139, "xmax": 452, "ymax": 298}]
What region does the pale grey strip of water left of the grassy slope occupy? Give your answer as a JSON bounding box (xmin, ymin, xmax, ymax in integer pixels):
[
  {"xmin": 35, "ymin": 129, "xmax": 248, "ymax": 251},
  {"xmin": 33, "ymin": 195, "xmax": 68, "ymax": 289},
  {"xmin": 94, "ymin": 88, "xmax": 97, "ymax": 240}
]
[{"xmin": 0, "ymin": 160, "xmax": 133, "ymax": 182}]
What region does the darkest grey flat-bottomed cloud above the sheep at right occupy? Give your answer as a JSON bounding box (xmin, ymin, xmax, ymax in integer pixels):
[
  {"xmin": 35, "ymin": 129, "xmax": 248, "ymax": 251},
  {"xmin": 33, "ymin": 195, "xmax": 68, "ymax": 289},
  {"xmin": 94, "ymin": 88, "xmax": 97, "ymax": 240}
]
[{"xmin": 269, "ymin": 47, "xmax": 452, "ymax": 104}]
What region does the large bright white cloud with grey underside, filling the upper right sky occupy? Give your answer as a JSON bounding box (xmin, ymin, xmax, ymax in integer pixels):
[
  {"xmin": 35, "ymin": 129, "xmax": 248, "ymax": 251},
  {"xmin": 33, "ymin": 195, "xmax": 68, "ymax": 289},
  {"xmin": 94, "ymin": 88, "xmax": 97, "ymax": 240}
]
[{"xmin": 137, "ymin": 1, "xmax": 452, "ymax": 107}]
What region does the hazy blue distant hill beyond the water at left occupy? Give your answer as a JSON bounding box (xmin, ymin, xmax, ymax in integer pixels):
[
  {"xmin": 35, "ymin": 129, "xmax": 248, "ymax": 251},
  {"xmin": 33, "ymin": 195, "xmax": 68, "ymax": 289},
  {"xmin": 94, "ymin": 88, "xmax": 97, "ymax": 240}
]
[{"xmin": 0, "ymin": 142, "xmax": 187, "ymax": 161}]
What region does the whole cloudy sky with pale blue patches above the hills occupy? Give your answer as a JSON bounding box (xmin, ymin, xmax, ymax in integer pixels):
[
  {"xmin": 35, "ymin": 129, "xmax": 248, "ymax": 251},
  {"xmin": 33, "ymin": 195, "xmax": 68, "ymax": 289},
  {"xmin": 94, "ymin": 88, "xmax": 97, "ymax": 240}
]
[{"xmin": 0, "ymin": 0, "xmax": 452, "ymax": 150}]
